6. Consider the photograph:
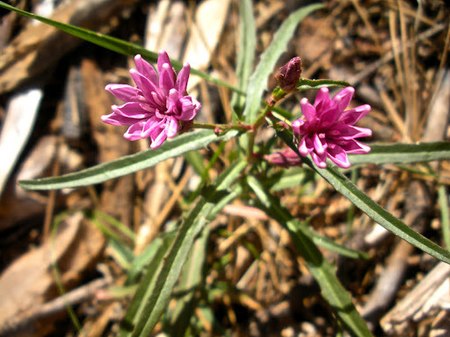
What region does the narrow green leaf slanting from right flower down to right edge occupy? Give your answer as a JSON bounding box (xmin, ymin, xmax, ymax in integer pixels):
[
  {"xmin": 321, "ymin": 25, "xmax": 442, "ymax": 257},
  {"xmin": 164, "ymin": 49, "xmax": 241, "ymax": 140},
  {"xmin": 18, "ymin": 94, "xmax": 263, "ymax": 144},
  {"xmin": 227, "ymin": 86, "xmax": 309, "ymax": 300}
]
[{"xmin": 314, "ymin": 163, "xmax": 450, "ymax": 264}]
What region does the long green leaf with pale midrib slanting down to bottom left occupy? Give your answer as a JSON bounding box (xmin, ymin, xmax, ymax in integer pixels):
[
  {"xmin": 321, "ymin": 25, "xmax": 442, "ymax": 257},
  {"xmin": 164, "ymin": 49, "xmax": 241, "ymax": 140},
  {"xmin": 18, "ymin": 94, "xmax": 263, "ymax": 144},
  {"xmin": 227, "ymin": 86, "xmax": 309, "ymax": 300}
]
[{"xmin": 120, "ymin": 162, "xmax": 247, "ymax": 337}]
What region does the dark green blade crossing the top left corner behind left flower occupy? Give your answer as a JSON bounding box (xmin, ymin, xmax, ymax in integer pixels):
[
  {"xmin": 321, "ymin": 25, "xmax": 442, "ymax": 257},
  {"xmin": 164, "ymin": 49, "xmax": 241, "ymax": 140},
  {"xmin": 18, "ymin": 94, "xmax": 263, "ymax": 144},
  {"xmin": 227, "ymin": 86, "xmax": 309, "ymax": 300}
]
[{"xmin": 0, "ymin": 1, "xmax": 243, "ymax": 95}]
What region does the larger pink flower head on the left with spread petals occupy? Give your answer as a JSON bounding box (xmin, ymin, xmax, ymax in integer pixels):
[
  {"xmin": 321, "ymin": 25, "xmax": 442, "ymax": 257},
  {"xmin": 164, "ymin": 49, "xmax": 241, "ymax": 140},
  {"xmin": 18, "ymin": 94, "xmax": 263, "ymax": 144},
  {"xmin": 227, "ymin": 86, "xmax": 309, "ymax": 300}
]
[{"xmin": 102, "ymin": 52, "xmax": 201, "ymax": 149}]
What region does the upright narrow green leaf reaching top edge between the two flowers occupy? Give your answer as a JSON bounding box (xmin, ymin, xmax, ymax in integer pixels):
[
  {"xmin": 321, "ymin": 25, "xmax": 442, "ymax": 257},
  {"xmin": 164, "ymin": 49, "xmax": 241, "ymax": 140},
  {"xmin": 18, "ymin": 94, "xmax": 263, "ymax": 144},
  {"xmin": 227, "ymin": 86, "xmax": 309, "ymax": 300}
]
[{"xmin": 231, "ymin": 0, "xmax": 256, "ymax": 116}]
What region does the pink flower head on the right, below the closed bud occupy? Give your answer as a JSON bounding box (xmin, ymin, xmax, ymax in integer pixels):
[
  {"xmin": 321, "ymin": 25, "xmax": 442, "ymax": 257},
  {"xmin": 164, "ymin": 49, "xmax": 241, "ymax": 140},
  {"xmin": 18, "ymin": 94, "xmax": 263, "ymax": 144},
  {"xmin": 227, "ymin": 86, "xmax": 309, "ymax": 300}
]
[{"xmin": 292, "ymin": 87, "xmax": 372, "ymax": 168}]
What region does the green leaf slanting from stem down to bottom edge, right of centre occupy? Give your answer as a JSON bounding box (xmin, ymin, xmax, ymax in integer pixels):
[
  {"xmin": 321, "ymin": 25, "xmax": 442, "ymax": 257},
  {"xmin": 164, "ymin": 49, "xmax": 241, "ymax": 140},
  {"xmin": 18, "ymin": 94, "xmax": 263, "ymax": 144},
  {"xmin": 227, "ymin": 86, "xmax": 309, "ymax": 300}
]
[{"xmin": 247, "ymin": 176, "xmax": 372, "ymax": 337}]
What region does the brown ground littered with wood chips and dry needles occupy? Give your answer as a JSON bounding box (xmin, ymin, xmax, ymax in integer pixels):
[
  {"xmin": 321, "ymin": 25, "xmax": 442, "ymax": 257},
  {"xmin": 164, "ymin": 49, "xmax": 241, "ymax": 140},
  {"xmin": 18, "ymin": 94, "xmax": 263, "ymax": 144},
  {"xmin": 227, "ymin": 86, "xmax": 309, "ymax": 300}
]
[{"xmin": 0, "ymin": 0, "xmax": 450, "ymax": 337}]
